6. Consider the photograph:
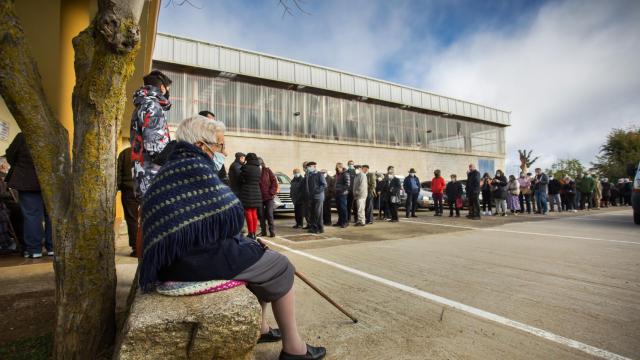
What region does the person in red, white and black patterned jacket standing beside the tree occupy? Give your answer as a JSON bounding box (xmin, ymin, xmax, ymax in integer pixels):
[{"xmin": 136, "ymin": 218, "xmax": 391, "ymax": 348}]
[{"xmin": 130, "ymin": 70, "xmax": 171, "ymax": 199}]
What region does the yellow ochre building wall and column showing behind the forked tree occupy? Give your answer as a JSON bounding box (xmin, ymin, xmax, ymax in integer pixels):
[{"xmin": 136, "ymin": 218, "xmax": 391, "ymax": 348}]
[{"xmin": 5, "ymin": 0, "xmax": 160, "ymax": 218}]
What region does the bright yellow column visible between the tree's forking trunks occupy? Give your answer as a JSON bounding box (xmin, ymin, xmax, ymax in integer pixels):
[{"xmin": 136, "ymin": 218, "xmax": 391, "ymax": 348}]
[{"xmin": 58, "ymin": 0, "xmax": 92, "ymax": 139}]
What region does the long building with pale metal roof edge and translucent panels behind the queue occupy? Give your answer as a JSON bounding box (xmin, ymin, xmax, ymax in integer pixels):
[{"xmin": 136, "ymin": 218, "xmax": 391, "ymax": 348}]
[{"xmin": 153, "ymin": 34, "xmax": 509, "ymax": 179}]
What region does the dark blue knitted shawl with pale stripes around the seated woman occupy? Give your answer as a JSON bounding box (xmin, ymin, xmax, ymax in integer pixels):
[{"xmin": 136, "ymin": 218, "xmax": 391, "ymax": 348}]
[{"xmin": 139, "ymin": 142, "xmax": 244, "ymax": 291}]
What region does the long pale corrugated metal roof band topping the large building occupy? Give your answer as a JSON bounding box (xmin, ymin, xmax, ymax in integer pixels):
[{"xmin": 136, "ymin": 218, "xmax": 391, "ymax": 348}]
[{"xmin": 153, "ymin": 33, "xmax": 510, "ymax": 126}]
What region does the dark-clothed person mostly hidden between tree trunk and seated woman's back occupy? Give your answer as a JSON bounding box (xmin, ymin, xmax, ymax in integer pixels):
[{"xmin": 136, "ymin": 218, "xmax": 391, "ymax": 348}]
[{"xmin": 116, "ymin": 147, "xmax": 140, "ymax": 256}]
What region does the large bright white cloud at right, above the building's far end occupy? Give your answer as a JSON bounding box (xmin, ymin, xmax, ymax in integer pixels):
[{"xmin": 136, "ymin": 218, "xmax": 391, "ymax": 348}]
[{"xmin": 411, "ymin": 1, "xmax": 640, "ymax": 167}]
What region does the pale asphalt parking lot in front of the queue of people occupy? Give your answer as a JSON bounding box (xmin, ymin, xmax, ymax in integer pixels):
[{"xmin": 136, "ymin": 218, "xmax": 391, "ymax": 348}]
[{"xmin": 249, "ymin": 208, "xmax": 640, "ymax": 360}]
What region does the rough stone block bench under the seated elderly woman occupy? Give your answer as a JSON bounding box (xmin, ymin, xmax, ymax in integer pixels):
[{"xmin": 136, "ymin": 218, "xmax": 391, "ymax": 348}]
[{"xmin": 114, "ymin": 286, "xmax": 261, "ymax": 360}]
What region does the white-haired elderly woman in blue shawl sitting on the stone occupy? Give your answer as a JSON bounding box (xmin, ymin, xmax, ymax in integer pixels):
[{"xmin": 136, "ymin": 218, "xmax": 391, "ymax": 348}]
[{"xmin": 140, "ymin": 116, "xmax": 326, "ymax": 359}]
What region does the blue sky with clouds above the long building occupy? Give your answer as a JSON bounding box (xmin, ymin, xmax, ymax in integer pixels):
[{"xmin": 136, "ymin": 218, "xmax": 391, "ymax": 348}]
[{"xmin": 158, "ymin": 0, "xmax": 640, "ymax": 172}]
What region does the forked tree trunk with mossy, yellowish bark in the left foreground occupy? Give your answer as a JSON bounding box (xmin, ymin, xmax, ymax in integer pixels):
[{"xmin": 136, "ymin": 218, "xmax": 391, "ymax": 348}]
[{"xmin": 0, "ymin": 0, "xmax": 144, "ymax": 359}]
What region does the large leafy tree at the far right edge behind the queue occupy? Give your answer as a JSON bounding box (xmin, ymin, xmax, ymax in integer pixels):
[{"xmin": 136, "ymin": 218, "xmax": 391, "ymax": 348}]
[{"xmin": 592, "ymin": 127, "xmax": 640, "ymax": 179}]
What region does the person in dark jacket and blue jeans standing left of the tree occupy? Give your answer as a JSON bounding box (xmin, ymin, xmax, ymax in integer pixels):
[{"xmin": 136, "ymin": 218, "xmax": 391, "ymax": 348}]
[{"xmin": 7, "ymin": 133, "xmax": 54, "ymax": 258}]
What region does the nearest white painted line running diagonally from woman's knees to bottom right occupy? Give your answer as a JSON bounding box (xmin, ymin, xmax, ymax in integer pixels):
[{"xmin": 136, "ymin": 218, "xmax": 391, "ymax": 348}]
[{"xmin": 264, "ymin": 240, "xmax": 631, "ymax": 360}]
